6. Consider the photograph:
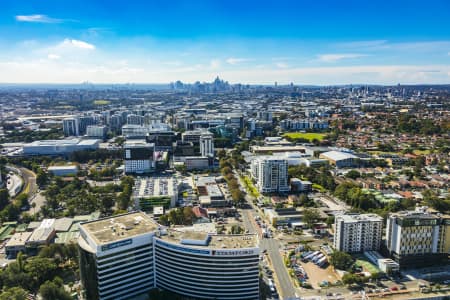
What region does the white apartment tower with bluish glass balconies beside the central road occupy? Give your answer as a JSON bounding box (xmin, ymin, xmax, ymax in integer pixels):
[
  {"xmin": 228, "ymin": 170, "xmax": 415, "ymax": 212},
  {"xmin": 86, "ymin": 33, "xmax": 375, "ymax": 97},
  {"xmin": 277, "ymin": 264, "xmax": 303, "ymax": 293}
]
[{"xmin": 251, "ymin": 156, "xmax": 289, "ymax": 193}]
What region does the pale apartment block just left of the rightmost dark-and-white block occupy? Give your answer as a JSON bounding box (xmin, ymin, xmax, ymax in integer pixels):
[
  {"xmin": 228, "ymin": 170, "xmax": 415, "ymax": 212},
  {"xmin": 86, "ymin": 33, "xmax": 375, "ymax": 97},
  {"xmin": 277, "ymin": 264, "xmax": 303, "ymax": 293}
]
[{"xmin": 333, "ymin": 214, "xmax": 383, "ymax": 253}]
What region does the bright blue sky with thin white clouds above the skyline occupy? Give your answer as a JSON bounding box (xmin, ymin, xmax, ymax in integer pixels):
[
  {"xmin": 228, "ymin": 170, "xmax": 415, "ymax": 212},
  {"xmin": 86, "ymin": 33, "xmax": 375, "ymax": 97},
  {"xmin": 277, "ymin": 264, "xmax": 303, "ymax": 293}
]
[{"xmin": 0, "ymin": 0, "xmax": 450, "ymax": 85}]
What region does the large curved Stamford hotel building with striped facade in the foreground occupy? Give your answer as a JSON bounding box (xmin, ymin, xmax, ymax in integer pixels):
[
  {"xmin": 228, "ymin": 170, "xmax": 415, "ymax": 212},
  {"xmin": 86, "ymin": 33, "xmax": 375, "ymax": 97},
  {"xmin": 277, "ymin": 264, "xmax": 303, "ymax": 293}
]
[{"xmin": 78, "ymin": 212, "xmax": 259, "ymax": 300}]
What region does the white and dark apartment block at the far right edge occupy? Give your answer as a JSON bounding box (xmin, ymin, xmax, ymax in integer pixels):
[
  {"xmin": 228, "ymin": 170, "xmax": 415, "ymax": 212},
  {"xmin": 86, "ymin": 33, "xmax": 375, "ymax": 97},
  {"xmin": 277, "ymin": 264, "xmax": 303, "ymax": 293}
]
[{"xmin": 386, "ymin": 207, "xmax": 450, "ymax": 268}]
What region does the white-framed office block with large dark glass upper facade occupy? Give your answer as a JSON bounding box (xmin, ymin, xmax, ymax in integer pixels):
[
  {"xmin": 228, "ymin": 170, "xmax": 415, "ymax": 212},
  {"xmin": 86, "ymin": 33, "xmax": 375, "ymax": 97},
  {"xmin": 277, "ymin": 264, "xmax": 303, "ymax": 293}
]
[{"xmin": 123, "ymin": 140, "xmax": 155, "ymax": 174}]
